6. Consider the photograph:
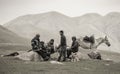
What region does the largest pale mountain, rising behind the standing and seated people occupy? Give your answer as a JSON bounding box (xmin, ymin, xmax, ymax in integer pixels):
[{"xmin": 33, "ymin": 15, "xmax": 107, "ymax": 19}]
[{"xmin": 4, "ymin": 11, "xmax": 77, "ymax": 41}]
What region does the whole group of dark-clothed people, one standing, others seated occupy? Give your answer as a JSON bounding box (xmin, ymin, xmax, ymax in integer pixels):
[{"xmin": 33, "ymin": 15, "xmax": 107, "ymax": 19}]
[{"xmin": 31, "ymin": 30, "xmax": 79, "ymax": 61}]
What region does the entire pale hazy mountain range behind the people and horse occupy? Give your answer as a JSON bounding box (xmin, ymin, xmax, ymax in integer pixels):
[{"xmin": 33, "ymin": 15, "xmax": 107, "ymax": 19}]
[{"xmin": 3, "ymin": 11, "xmax": 120, "ymax": 52}]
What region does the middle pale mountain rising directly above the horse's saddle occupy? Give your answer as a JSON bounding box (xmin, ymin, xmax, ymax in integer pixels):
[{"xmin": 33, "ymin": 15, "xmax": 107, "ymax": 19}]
[{"xmin": 74, "ymin": 13, "xmax": 104, "ymax": 37}]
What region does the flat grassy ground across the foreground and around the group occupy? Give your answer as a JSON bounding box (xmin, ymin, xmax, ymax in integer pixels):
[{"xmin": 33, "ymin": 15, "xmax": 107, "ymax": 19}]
[{"xmin": 0, "ymin": 46, "xmax": 120, "ymax": 74}]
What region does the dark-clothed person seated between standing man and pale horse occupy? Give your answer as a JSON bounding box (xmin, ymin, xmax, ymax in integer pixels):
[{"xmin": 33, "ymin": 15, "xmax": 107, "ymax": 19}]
[{"xmin": 67, "ymin": 36, "xmax": 79, "ymax": 58}]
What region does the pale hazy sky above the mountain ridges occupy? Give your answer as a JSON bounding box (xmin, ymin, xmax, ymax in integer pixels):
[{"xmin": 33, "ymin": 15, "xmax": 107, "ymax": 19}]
[{"xmin": 0, "ymin": 0, "xmax": 120, "ymax": 24}]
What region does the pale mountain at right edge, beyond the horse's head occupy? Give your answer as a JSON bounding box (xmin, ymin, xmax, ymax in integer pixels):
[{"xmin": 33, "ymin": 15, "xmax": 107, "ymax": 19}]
[{"xmin": 104, "ymin": 12, "xmax": 120, "ymax": 51}]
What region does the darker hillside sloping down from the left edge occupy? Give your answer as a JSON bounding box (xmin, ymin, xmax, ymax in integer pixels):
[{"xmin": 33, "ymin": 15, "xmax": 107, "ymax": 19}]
[{"xmin": 0, "ymin": 25, "xmax": 27, "ymax": 44}]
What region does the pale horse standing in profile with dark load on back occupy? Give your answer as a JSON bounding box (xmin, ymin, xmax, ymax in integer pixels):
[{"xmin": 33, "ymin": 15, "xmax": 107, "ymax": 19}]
[{"xmin": 77, "ymin": 36, "xmax": 111, "ymax": 49}]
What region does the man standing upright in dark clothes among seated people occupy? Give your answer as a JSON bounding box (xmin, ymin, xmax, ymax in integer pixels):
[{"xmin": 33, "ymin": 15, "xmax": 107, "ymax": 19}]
[{"xmin": 58, "ymin": 30, "xmax": 67, "ymax": 61}]
